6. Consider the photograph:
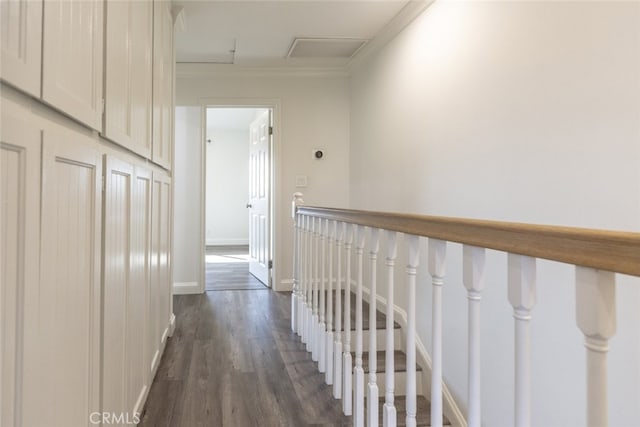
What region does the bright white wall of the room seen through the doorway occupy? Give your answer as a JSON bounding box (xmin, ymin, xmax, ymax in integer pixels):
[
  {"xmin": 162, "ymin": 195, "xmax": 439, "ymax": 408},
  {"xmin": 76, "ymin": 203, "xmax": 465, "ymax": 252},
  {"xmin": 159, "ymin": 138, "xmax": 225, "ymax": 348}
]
[{"xmin": 206, "ymin": 127, "xmax": 249, "ymax": 245}]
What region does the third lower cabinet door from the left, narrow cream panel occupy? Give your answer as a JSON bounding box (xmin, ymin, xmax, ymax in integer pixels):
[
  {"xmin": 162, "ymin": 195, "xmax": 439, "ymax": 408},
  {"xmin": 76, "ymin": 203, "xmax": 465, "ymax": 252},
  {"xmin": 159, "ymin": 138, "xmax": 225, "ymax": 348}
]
[{"xmin": 102, "ymin": 156, "xmax": 133, "ymax": 422}]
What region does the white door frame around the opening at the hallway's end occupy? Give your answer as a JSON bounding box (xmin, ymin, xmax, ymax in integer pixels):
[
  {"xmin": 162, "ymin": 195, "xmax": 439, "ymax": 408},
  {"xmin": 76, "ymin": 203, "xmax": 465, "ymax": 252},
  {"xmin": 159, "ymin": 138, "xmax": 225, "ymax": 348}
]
[{"xmin": 200, "ymin": 98, "xmax": 281, "ymax": 293}]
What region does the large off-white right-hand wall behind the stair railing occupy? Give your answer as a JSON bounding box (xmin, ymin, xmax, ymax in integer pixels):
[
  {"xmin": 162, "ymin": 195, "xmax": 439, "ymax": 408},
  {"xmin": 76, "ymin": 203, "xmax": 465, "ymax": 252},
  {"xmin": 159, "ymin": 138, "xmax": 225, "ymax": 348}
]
[{"xmin": 349, "ymin": 1, "xmax": 640, "ymax": 426}]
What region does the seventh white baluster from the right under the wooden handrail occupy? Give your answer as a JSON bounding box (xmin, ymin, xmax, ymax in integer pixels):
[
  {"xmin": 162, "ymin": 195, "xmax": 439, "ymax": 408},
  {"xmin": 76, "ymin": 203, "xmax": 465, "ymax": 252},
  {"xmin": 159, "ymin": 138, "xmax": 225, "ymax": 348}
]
[{"xmin": 367, "ymin": 228, "xmax": 380, "ymax": 427}]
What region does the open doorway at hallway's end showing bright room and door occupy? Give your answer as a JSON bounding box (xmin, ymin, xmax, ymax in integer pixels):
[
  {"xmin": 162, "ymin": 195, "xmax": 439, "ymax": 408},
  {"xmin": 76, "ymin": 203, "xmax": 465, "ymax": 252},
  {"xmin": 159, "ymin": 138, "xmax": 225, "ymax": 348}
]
[{"xmin": 204, "ymin": 107, "xmax": 272, "ymax": 291}]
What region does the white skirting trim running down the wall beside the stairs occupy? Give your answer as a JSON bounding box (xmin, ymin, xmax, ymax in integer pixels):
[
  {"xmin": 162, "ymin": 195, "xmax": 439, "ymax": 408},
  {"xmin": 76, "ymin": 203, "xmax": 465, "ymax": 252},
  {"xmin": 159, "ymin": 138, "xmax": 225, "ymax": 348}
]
[{"xmin": 351, "ymin": 280, "xmax": 467, "ymax": 427}]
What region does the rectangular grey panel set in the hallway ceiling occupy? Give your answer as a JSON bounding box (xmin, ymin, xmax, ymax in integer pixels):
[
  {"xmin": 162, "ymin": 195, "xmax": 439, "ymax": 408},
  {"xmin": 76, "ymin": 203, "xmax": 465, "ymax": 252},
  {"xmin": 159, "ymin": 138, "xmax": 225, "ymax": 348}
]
[{"xmin": 287, "ymin": 38, "xmax": 367, "ymax": 58}]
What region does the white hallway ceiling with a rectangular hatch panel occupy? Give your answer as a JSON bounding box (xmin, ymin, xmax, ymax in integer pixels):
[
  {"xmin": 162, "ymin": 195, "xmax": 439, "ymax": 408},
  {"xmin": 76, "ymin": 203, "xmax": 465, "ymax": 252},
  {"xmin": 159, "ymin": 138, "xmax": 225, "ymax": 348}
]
[{"xmin": 173, "ymin": 0, "xmax": 409, "ymax": 67}]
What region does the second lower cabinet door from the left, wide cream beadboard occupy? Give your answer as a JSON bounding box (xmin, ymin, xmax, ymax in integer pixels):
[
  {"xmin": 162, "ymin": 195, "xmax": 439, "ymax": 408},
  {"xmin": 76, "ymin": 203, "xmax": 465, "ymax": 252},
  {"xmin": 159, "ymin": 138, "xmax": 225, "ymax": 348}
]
[{"xmin": 39, "ymin": 129, "xmax": 102, "ymax": 426}]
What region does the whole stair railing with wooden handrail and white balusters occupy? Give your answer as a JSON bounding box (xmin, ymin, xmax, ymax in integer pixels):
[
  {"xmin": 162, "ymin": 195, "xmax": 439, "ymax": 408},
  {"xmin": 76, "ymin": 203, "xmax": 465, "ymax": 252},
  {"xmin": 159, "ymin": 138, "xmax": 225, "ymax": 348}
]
[{"xmin": 292, "ymin": 193, "xmax": 640, "ymax": 427}]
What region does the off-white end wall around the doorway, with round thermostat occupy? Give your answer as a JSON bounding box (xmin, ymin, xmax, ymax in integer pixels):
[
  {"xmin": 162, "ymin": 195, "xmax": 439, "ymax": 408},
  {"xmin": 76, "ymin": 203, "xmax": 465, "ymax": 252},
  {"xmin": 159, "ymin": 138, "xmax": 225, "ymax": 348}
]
[{"xmin": 173, "ymin": 70, "xmax": 349, "ymax": 290}]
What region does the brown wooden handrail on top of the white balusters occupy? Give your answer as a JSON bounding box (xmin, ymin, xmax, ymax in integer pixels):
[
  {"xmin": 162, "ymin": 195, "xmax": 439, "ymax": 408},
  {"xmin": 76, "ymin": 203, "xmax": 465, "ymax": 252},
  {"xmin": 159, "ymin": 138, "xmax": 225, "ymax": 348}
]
[{"xmin": 296, "ymin": 206, "xmax": 640, "ymax": 276}]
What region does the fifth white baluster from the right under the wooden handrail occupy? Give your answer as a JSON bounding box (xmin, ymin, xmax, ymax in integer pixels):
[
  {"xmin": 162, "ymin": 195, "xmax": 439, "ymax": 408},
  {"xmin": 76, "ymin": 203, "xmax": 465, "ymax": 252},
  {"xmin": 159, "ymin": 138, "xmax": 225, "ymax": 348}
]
[{"xmin": 406, "ymin": 235, "xmax": 420, "ymax": 427}]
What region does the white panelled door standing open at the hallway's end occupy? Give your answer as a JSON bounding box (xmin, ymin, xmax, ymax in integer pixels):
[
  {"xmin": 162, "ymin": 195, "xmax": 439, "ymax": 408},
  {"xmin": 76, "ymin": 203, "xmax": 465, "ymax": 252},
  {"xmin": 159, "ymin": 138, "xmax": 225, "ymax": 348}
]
[{"xmin": 247, "ymin": 110, "xmax": 271, "ymax": 286}]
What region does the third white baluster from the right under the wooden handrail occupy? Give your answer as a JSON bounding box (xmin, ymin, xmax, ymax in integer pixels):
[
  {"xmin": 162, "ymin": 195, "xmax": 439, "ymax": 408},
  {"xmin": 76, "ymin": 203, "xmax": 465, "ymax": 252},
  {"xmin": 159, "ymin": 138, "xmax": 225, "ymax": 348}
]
[{"xmin": 462, "ymin": 245, "xmax": 485, "ymax": 427}]
